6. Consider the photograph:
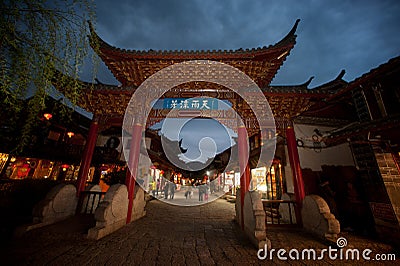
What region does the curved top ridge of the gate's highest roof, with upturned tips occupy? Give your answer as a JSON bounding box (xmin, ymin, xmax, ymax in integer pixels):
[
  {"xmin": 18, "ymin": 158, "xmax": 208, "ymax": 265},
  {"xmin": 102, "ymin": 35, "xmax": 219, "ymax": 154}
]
[{"xmin": 88, "ymin": 19, "xmax": 300, "ymax": 56}]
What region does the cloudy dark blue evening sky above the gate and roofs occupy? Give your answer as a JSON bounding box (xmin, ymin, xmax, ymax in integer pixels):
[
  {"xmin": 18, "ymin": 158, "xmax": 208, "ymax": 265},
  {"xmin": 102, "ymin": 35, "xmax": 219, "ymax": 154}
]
[{"xmin": 86, "ymin": 0, "xmax": 400, "ymax": 88}]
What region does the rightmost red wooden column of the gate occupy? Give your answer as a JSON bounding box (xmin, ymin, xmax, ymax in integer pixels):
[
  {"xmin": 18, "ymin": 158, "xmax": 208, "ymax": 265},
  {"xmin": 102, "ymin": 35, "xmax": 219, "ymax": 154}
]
[{"xmin": 286, "ymin": 126, "xmax": 305, "ymax": 222}]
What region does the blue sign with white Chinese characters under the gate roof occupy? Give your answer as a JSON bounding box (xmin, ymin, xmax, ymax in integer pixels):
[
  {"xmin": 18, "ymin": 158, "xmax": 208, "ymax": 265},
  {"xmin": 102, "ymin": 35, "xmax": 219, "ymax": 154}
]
[{"xmin": 163, "ymin": 98, "xmax": 218, "ymax": 110}]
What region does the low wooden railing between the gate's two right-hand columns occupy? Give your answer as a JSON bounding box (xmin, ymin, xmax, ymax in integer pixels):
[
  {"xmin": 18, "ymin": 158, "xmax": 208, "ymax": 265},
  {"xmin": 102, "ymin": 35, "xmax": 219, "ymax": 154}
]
[{"xmin": 262, "ymin": 199, "xmax": 297, "ymax": 226}]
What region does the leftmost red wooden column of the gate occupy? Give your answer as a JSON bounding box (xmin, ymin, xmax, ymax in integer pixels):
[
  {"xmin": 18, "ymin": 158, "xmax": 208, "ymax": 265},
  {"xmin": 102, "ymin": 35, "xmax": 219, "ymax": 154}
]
[{"xmin": 76, "ymin": 116, "xmax": 99, "ymax": 197}]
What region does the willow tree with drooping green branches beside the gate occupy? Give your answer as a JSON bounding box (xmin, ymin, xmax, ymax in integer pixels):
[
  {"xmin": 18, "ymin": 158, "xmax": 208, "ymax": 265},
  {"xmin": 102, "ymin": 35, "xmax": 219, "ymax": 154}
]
[{"xmin": 0, "ymin": 0, "xmax": 96, "ymax": 152}]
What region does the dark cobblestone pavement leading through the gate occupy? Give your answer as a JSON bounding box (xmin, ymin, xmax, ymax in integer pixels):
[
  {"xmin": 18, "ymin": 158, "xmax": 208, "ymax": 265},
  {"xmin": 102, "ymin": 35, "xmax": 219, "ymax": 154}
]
[{"xmin": 0, "ymin": 199, "xmax": 399, "ymax": 265}]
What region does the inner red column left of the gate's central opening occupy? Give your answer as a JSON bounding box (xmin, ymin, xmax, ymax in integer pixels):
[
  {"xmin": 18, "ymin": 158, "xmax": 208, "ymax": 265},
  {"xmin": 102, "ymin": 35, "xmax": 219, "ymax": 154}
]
[{"xmin": 125, "ymin": 123, "xmax": 143, "ymax": 224}]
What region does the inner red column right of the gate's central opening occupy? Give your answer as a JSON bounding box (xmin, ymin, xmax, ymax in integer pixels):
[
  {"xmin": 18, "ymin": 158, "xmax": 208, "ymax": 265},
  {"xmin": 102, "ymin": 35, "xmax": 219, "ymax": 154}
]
[{"xmin": 236, "ymin": 126, "xmax": 250, "ymax": 229}]
